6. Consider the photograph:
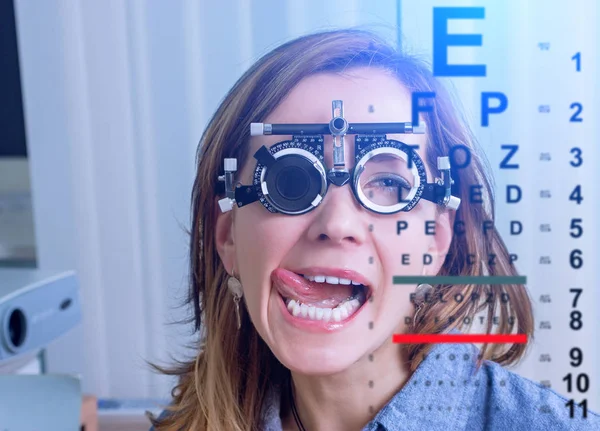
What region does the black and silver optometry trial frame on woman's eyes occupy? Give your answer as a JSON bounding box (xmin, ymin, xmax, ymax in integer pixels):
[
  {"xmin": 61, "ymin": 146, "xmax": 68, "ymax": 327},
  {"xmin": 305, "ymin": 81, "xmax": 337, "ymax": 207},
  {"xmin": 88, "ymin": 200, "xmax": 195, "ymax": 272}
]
[{"xmin": 218, "ymin": 100, "xmax": 460, "ymax": 215}]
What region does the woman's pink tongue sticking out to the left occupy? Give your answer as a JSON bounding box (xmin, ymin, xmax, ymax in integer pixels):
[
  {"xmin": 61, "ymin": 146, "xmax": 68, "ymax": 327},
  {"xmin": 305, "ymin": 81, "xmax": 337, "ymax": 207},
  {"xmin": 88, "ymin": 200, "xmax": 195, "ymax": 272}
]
[{"xmin": 271, "ymin": 268, "xmax": 354, "ymax": 308}]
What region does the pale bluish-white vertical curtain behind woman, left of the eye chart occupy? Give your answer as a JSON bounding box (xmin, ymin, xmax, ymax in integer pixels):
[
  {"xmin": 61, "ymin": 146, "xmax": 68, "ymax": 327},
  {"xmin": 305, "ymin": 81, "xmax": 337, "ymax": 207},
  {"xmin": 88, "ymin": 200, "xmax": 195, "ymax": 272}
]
[{"xmin": 15, "ymin": 0, "xmax": 398, "ymax": 398}]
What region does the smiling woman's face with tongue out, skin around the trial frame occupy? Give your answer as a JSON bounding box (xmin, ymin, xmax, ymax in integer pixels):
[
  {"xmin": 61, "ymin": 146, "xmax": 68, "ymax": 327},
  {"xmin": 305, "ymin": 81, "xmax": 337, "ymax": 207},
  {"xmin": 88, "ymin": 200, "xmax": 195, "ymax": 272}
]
[{"xmin": 217, "ymin": 68, "xmax": 451, "ymax": 374}]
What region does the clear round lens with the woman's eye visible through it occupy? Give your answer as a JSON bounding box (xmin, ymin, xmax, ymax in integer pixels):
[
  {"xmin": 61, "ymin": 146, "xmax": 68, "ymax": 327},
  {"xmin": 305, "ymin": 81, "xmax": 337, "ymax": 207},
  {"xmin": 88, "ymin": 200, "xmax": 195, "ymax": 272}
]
[{"xmin": 356, "ymin": 151, "xmax": 418, "ymax": 208}]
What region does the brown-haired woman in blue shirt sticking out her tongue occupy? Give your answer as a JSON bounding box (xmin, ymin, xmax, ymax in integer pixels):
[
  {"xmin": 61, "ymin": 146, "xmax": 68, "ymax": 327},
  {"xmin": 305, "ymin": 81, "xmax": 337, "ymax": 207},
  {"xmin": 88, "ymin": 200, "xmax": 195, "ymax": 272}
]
[{"xmin": 149, "ymin": 30, "xmax": 598, "ymax": 431}]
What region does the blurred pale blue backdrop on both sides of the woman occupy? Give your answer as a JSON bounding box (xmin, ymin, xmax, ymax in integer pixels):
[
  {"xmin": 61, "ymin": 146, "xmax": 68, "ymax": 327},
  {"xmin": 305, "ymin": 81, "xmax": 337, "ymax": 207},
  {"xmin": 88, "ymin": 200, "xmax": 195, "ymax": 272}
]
[{"xmin": 0, "ymin": 0, "xmax": 600, "ymax": 426}]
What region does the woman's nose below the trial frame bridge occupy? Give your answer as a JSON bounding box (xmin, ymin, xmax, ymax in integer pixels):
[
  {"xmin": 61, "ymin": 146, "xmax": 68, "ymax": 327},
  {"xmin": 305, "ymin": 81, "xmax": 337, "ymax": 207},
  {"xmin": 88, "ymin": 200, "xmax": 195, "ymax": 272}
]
[{"xmin": 309, "ymin": 183, "xmax": 368, "ymax": 245}]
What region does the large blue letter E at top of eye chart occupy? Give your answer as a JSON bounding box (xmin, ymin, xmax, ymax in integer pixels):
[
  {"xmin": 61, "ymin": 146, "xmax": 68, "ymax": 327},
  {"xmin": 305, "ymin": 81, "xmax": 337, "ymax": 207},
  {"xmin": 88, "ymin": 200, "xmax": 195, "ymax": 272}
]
[{"xmin": 433, "ymin": 7, "xmax": 485, "ymax": 76}]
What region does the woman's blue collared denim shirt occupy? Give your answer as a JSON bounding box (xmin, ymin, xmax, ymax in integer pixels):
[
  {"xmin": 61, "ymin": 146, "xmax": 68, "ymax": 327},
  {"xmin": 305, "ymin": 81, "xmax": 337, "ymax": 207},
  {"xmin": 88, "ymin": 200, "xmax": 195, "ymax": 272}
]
[{"xmin": 263, "ymin": 338, "xmax": 600, "ymax": 431}]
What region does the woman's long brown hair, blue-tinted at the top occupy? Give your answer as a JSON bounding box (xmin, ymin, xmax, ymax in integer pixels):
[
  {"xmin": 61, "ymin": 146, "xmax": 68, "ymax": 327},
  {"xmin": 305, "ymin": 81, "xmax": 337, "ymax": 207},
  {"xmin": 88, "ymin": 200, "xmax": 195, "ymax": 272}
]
[{"xmin": 153, "ymin": 29, "xmax": 533, "ymax": 431}]
